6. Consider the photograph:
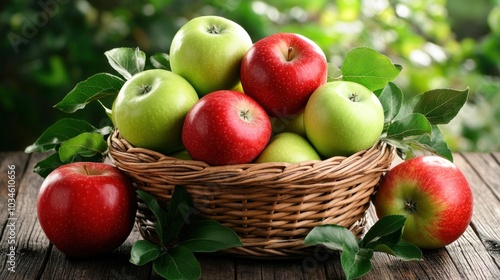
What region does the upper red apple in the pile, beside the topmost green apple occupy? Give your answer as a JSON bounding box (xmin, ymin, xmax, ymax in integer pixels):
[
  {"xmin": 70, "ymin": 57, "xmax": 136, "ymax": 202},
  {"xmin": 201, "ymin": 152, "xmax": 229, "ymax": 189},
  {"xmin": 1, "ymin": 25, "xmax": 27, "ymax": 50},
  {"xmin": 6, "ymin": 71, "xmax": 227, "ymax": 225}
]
[{"xmin": 240, "ymin": 33, "xmax": 328, "ymax": 117}]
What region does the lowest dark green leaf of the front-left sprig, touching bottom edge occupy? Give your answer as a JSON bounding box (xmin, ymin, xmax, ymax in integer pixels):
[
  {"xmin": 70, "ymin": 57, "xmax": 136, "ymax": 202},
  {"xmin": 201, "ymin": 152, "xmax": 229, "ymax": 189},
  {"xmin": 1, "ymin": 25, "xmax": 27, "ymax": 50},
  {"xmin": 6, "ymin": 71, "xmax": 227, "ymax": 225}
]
[{"xmin": 153, "ymin": 246, "xmax": 201, "ymax": 279}]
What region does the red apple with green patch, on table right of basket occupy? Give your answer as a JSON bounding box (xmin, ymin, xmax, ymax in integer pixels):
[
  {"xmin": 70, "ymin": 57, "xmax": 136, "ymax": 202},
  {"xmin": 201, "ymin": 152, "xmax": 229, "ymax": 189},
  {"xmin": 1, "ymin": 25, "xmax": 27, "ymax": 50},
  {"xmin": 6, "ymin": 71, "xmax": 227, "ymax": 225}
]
[{"xmin": 374, "ymin": 156, "xmax": 473, "ymax": 249}]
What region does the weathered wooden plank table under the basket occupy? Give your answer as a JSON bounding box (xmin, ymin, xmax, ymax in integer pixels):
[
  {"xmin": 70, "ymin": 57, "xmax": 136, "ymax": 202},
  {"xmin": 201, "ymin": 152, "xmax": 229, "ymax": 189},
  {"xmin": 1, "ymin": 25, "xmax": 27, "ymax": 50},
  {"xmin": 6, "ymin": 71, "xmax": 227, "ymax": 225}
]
[{"xmin": 0, "ymin": 152, "xmax": 500, "ymax": 280}]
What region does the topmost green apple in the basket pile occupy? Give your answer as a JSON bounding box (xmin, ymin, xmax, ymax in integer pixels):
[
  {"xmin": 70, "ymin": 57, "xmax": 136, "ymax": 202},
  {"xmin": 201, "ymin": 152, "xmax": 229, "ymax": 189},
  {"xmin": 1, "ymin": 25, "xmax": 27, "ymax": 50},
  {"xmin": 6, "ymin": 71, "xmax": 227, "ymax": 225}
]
[{"xmin": 170, "ymin": 16, "xmax": 253, "ymax": 96}]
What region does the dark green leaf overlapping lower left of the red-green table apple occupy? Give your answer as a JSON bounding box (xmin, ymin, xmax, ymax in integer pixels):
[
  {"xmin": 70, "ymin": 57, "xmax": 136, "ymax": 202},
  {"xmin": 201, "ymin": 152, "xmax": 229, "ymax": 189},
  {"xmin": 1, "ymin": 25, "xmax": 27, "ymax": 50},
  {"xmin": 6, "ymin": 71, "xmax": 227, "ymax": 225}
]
[{"xmin": 362, "ymin": 215, "xmax": 406, "ymax": 248}]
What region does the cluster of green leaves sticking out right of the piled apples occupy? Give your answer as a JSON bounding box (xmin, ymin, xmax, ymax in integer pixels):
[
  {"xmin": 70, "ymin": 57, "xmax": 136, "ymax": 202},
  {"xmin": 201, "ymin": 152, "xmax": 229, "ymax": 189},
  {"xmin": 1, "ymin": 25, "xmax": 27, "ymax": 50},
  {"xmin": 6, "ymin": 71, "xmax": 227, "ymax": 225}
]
[{"xmin": 328, "ymin": 47, "xmax": 469, "ymax": 161}]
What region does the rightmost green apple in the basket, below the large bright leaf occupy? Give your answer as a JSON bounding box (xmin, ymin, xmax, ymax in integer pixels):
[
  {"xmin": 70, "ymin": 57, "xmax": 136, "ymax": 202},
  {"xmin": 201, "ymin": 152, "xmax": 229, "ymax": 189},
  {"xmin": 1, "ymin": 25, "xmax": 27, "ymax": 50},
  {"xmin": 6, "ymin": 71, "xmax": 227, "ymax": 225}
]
[{"xmin": 304, "ymin": 81, "xmax": 384, "ymax": 157}]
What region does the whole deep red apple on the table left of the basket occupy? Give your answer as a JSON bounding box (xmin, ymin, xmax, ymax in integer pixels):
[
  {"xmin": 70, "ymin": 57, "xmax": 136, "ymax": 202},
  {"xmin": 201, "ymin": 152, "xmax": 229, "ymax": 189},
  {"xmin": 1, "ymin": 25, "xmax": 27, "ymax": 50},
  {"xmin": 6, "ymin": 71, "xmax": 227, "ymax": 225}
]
[{"xmin": 37, "ymin": 162, "xmax": 137, "ymax": 257}]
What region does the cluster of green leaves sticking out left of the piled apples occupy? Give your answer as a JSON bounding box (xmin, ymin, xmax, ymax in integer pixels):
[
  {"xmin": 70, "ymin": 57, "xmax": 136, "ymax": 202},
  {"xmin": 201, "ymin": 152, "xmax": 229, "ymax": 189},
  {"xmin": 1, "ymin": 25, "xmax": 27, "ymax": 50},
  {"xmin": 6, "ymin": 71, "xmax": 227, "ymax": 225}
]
[{"xmin": 25, "ymin": 48, "xmax": 168, "ymax": 178}]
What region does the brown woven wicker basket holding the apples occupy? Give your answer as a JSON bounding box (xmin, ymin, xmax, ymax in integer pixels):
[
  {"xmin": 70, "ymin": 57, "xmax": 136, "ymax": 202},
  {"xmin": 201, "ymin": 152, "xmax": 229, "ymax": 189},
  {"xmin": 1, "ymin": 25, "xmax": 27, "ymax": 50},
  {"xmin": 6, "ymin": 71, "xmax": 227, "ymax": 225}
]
[{"xmin": 108, "ymin": 130, "xmax": 394, "ymax": 258}]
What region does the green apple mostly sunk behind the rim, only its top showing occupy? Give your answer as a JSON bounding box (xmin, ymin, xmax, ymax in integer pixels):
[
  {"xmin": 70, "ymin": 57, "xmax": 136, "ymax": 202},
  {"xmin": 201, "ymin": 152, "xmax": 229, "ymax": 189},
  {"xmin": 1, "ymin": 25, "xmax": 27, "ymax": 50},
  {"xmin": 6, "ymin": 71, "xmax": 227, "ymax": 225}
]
[{"xmin": 255, "ymin": 132, "xmax": 321, "ymax": 163}]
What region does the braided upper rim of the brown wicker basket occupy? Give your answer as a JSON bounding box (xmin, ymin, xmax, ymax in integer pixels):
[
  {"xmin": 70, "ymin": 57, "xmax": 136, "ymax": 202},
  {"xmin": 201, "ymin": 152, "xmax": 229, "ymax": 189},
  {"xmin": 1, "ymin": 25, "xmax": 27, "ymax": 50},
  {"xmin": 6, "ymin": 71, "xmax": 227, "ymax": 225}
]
[{"xmin": 108, "ymin": 129, "xmax": 394, "ymax": 189}]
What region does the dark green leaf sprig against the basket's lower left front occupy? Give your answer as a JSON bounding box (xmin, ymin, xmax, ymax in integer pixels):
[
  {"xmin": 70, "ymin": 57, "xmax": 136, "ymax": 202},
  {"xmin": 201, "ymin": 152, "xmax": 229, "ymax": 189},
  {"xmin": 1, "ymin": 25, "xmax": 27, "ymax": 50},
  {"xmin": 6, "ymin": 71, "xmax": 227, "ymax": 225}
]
[{"xmin": 130, "ymin": 186, "xmax": 242, "ymax": 279}]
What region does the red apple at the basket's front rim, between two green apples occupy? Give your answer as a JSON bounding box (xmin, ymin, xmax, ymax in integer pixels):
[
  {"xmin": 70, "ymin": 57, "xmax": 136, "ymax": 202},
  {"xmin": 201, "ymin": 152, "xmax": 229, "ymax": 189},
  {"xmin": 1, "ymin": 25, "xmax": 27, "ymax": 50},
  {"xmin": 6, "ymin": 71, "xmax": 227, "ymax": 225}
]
[{"xmin": 182, "ymin": 90, "xmax": 271, "ymax": 165}]
